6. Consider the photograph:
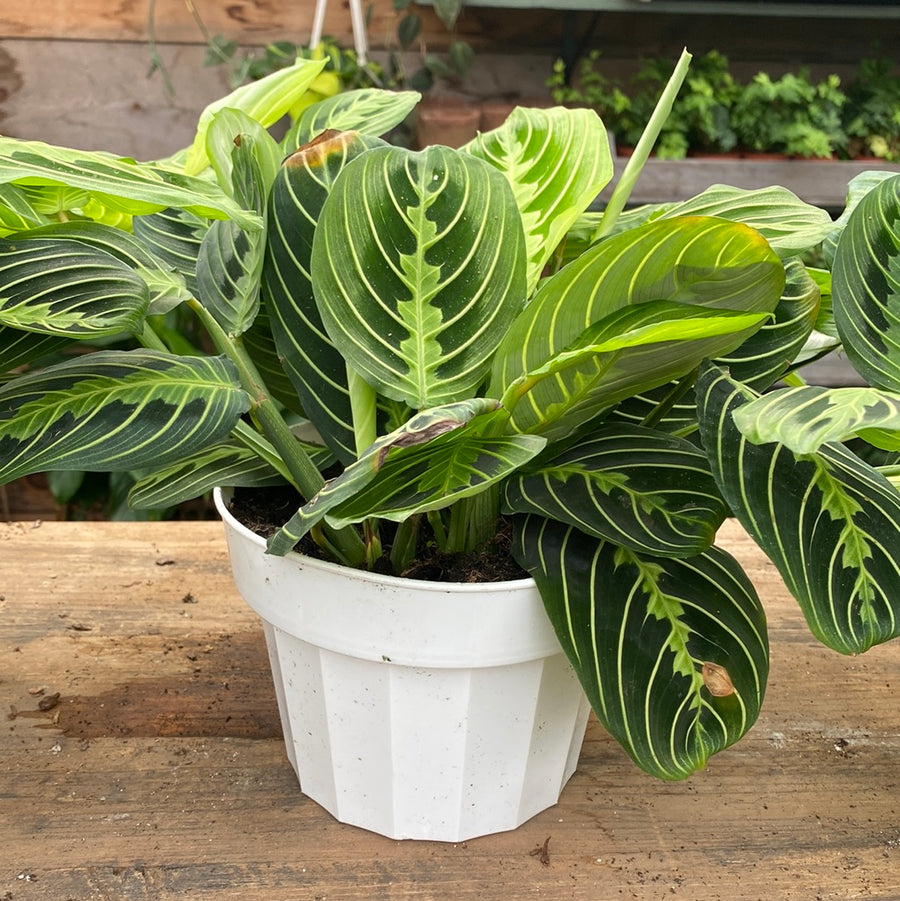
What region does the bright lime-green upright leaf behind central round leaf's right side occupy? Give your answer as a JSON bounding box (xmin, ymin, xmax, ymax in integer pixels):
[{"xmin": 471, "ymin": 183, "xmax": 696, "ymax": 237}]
[{"xmin": 463, "ymin": 107, "xmax": 613, "ymax": 295}]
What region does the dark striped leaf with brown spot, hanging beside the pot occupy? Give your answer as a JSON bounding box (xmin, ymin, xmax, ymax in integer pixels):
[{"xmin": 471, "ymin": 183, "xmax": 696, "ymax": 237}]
[{"xmin": 513, "ymin": 516, "xmax": 769, "ymax": 780}]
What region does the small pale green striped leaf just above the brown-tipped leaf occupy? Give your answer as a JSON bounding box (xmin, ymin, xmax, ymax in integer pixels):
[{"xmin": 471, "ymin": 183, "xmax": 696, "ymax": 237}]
[{"xmin": 283, "ymin": 88, "xmax": 421, "ymax": 154}]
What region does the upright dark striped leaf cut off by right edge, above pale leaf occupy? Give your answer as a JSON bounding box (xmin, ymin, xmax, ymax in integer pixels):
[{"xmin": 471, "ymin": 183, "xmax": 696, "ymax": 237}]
[{"xmin": 831, "ymin": 175, "xmax": 900, "ymax": 391}]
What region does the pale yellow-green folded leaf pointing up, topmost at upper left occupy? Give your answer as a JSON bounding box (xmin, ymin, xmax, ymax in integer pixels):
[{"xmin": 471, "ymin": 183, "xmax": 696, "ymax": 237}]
[{"xmin": 184, "ymin": 57, "xmax": 327, "ymax": 175}]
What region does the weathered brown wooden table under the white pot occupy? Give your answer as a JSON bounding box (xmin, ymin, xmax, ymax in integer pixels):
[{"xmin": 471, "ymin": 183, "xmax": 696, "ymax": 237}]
[{"xmin": 0, "ymin": 522, "xmax": 900, "ymax": 901}]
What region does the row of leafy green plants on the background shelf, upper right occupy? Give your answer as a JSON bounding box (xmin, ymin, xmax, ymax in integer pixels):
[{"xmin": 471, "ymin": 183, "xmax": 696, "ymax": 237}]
[{"xmin": 547, "ymin": 51, "xmax": 900, "ymax": 161}]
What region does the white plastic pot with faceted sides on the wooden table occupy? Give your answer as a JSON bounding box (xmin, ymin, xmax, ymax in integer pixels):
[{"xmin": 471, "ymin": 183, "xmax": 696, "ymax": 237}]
[{"xmin": 216, "ymin": 490, "xmax": 589, "ymax": 842}]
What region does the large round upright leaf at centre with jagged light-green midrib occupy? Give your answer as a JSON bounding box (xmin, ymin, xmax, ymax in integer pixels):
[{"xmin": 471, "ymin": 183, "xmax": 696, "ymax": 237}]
[{"xmin": 311, "ymin": 146, "xmax": 525, "ymax": 410}]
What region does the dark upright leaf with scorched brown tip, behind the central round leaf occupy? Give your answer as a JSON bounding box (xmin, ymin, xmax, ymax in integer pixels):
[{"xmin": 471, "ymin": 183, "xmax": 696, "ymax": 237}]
[{"xmin": 262, "ymin": 132, "xmax": 384, "ymax": 463}]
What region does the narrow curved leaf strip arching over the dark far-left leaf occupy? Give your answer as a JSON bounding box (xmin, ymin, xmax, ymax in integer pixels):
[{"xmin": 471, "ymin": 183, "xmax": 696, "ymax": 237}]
[{"xmin": 8, "ymin": 220, "xmax": 191, "ymax": 315}]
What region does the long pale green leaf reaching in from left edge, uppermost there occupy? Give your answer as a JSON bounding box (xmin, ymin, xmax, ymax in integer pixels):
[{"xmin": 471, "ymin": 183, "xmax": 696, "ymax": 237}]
[{"xmin": 0, "ymin": 136, "xmax": 262, "ymax": 229}]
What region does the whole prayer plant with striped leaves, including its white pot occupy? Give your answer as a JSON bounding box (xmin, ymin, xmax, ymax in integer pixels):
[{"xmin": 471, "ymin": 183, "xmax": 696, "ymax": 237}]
[{"xmin": 0, "ymin": 55, "xmax": 900, "ymax": 840}]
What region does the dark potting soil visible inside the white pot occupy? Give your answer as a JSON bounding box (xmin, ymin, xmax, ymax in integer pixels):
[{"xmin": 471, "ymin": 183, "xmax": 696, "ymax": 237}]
[{"xmin": 231, "ymin": 486, "xmax": 528, "ymax": 582}]
